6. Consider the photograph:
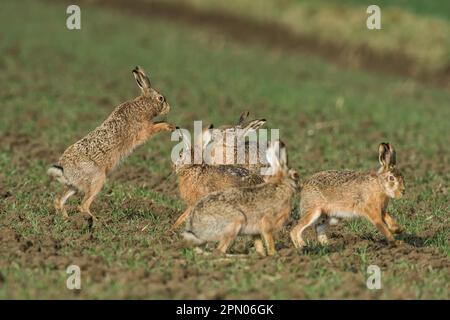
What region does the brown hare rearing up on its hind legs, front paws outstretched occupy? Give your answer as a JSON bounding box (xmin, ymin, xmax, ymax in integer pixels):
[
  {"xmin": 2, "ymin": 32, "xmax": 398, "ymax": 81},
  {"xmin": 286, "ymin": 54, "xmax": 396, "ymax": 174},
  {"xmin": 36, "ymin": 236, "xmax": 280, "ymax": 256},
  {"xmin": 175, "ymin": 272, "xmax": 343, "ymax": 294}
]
[{"xmin": 48, "ymin": 67, "xmax": 175, "ymax": 218}]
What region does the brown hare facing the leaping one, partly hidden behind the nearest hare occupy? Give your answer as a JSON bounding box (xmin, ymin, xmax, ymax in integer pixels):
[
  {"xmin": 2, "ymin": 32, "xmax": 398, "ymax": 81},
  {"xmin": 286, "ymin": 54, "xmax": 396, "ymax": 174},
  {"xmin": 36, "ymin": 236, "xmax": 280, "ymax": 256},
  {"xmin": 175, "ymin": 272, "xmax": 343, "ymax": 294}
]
[{"xmin": 172, "ymin": 131, "xmax": 264, "ymax": 229}]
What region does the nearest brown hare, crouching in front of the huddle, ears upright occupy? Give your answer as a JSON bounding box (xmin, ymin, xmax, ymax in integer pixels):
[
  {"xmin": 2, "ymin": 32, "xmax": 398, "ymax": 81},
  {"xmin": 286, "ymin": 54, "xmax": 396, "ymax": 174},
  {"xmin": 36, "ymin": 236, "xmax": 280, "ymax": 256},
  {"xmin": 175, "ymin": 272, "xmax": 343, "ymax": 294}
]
[{"xmin": 183, "ymin": 142, "xmax": 298, "ymax": 255}]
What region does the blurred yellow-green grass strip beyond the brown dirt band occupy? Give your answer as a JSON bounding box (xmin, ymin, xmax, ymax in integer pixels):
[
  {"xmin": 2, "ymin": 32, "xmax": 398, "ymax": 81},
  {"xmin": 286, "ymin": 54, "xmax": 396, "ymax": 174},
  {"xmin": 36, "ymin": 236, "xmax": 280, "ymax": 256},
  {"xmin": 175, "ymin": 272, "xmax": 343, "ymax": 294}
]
[{"xmin": 172, "ymin": 0, "xmax": 450, "ymax": 74}]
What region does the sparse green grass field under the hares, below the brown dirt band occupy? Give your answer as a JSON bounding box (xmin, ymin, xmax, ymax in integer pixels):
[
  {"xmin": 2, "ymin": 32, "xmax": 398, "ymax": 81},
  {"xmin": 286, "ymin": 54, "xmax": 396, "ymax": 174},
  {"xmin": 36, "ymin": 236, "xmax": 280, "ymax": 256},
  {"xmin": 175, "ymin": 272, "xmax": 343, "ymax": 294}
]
[{"xmin": 0, "ymin": 0, "xmax": 450, "ymax": 299}]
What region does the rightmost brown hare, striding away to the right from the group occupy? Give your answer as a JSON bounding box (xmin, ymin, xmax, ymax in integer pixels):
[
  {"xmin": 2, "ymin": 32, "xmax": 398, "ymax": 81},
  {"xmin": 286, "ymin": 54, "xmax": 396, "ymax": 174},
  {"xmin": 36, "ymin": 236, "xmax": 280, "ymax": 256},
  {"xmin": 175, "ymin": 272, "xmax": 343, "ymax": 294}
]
[{"xmin": 291, "ymin": 143, "xmax": 405, "ymax": 248}]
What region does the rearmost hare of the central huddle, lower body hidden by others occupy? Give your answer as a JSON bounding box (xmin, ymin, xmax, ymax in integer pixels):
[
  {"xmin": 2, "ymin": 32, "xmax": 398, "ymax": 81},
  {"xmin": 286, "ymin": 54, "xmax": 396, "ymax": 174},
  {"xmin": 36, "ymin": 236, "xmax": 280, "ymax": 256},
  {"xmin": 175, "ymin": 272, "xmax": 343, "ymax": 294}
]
[{"xmin": 202, "ymin": 111, "xmax": 267, "ymax": 175}]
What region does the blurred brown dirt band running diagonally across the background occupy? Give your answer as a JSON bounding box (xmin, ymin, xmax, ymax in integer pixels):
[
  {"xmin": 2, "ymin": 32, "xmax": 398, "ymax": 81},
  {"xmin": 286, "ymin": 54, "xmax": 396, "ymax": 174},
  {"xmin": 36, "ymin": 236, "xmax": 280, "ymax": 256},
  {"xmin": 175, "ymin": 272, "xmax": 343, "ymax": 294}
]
[{"xmin": 51, "ymin": 0, "xmax": 450, "ymax": 86}]
